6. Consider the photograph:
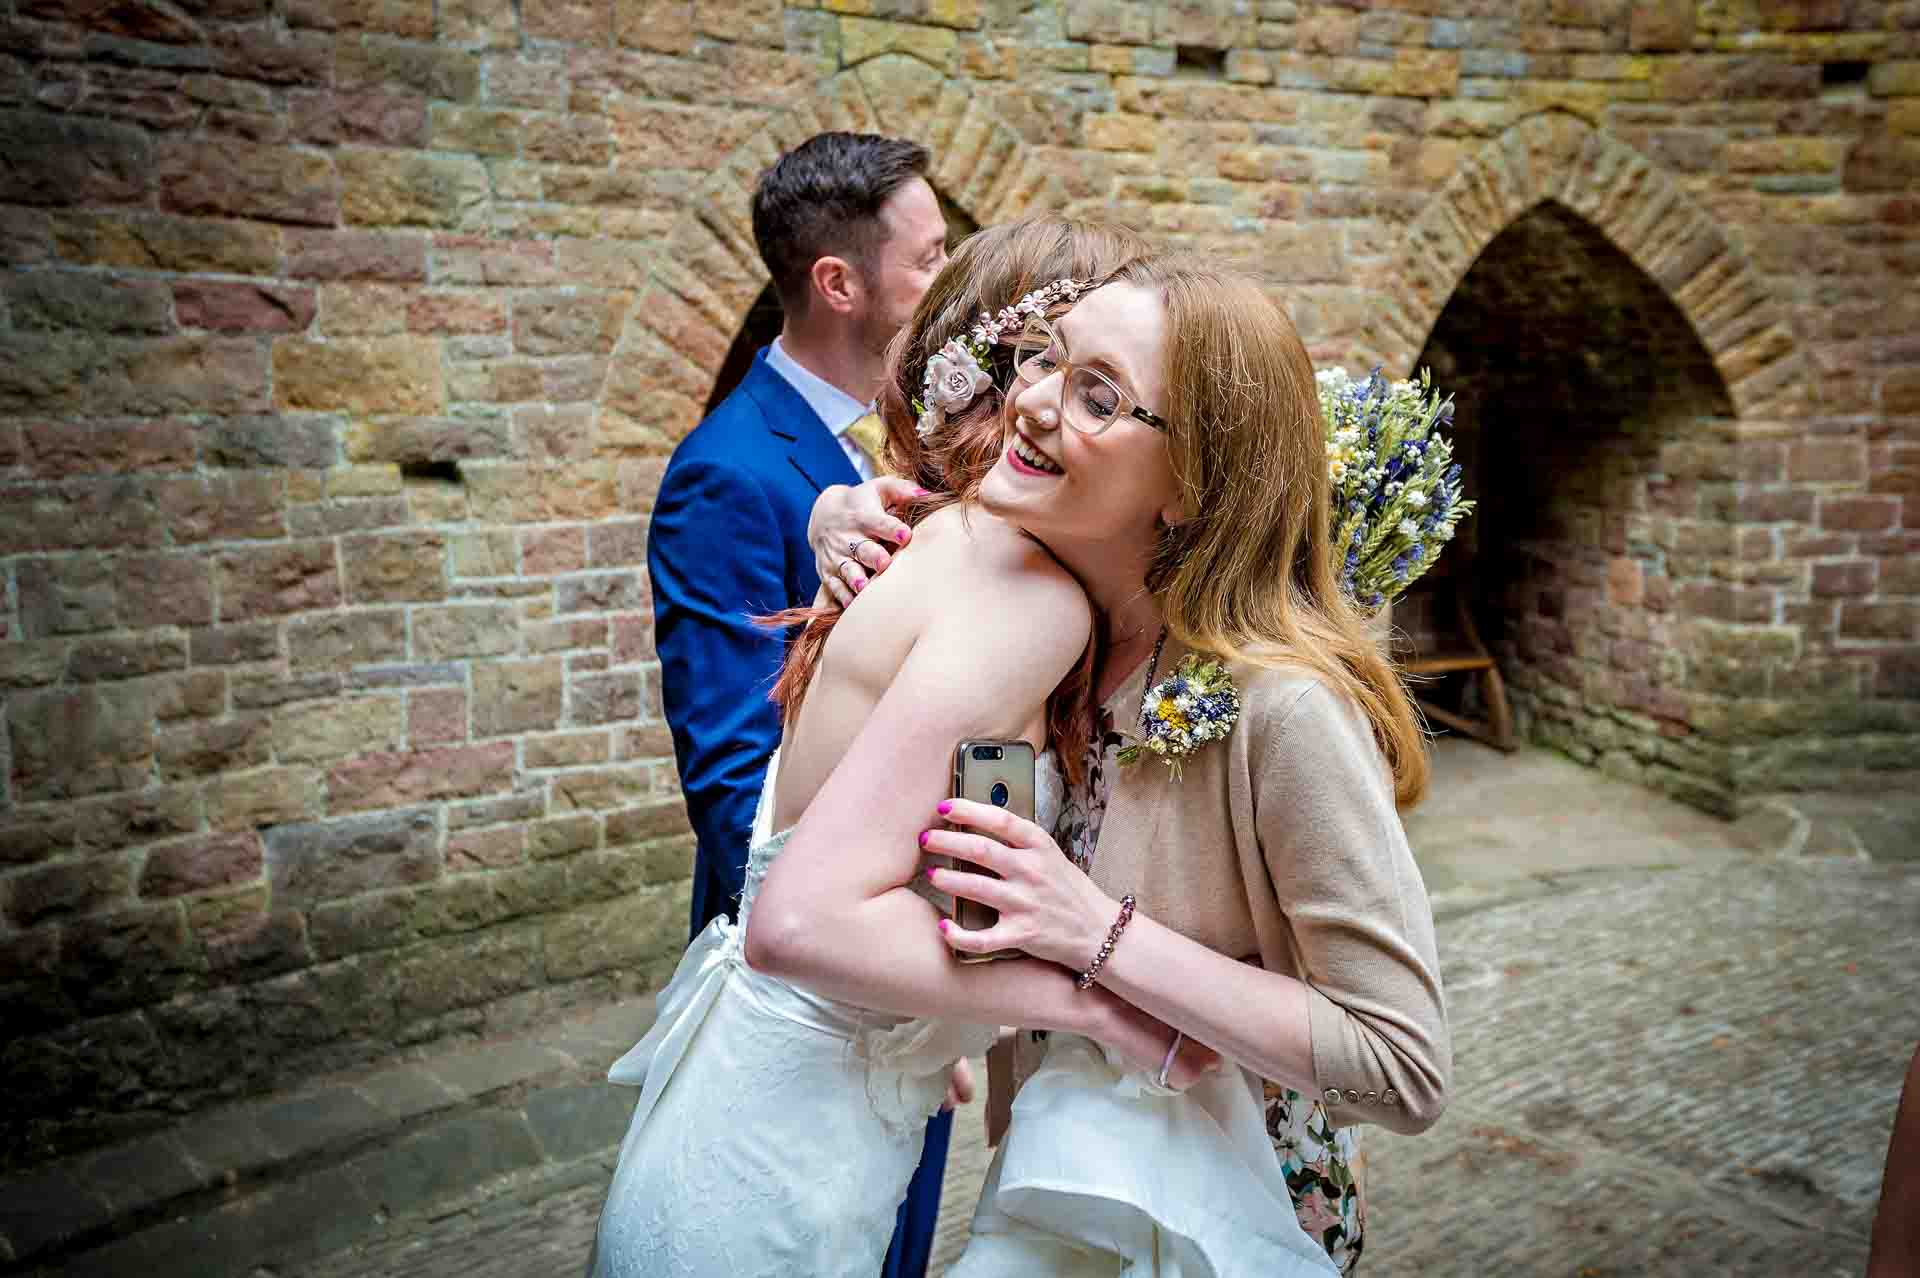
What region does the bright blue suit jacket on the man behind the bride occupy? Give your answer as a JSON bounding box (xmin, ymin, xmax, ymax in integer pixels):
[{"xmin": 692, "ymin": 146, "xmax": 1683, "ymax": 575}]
[{"xmin": 647, "ymin": 349, "xmax": 860, "ymax": 935}]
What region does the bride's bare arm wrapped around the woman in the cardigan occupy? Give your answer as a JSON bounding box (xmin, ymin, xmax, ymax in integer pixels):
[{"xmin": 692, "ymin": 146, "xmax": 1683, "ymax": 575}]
[{"xmin": 747, "ymin": 574, "xmax": 1169, "ymax": 1067}]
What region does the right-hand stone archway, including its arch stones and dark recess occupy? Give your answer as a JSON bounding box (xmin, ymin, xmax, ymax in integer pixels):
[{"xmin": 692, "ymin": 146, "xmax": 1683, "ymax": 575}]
[{"xmin": 1367, "ymin": 115, "xmax": 1811, "ymax": 814}]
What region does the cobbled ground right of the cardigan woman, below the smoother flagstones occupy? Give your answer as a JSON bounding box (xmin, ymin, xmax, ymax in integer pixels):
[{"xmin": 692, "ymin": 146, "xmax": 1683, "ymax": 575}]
[{"xmin": 1367, "ymin": 862, "xmax": 1920, "ymax": 1278}]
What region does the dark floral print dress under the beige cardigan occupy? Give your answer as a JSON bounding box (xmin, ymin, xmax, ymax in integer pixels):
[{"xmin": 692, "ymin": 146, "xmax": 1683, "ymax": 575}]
[{"xmin": 1054, "ymin": 710, "xmax": 1367, "ymax": 1274}]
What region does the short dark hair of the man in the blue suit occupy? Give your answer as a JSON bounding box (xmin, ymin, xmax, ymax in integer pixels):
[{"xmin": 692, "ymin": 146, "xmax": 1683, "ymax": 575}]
[{"xmin": 753, "ymin": 132, "xmax": 931, "ymax": 315}]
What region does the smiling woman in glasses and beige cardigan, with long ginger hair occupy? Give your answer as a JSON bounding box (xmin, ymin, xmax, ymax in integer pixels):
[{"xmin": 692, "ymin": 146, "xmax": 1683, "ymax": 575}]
[{"xmin": 814, "ymin": 259, "xmax": 1452, "ymax": 1272}]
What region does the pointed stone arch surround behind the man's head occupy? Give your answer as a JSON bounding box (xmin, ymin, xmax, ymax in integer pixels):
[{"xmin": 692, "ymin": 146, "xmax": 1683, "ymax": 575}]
[{"xmin": 595, "ymin": 54, "xmax": 1068, "ymax": 455}]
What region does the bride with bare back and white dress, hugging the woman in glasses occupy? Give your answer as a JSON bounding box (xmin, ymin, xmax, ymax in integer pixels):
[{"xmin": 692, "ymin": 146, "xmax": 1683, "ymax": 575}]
[{"xmin": 591, "ymin": 219, "xmax": 1213, "ymax": 1278}]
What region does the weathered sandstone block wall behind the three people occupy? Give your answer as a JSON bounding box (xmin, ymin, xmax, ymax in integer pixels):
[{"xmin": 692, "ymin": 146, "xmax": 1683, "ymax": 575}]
[{"xmin": 0, "ymin": 0, "xmax": 1920, "ymax": 1159}]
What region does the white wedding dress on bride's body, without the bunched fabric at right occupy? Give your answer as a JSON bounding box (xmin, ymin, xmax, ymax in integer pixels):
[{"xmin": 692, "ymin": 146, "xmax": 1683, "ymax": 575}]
[{"xmin": 589, "ymin": 752, "xmax": 1064, "ymax": 1278}]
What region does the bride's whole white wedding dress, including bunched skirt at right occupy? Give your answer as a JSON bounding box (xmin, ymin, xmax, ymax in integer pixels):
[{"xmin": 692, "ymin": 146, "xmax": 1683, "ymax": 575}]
[{"xmin": 589, "ymin": 752, "xmax": 1336, "ymax": 1278}]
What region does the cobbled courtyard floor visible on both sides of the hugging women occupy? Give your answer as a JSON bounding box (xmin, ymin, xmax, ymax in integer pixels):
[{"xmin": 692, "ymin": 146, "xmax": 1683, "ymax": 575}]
[{"xmin": 282, "ymin": 740, "xmax": 1920, "ymax": 1278}]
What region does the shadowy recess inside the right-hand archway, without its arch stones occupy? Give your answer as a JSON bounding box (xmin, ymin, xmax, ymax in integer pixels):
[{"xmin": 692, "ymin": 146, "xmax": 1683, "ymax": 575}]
[{"xmin": 1394, "ymin": 201, "xmax": 1738, "ymax": 781}]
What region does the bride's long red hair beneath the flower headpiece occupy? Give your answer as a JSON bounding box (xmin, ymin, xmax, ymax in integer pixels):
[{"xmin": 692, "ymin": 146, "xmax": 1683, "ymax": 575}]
[{"xmin": 760, "ymin": 217, "xmax": 1150, "ymax": 781}]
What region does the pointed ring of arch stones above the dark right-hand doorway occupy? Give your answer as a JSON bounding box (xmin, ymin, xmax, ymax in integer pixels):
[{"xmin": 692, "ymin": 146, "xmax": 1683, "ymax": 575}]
[{"xmin": 1369, "ymin": 111, "xmax": 1809, "ymax": 416}]
